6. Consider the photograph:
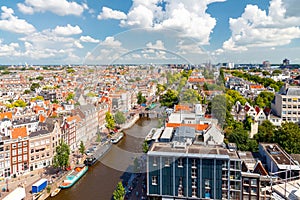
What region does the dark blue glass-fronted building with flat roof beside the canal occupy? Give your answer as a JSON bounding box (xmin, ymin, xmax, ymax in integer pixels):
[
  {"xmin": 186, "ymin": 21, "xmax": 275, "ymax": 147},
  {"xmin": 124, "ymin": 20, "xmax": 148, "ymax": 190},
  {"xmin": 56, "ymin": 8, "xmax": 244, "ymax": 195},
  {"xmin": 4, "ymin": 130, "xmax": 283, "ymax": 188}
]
[{"xmin": 147, "ymin": 143, "xmax": 242, "ymax": 199}]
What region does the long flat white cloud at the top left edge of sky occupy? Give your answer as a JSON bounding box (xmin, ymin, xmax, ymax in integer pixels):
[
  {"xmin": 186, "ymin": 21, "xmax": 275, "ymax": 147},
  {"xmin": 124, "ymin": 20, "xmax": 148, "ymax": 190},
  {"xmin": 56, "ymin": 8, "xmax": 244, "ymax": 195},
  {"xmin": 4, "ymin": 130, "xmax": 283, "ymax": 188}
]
[{"xmin": 18, "ymin": 0, "xmax": 88, "ymax": 16}]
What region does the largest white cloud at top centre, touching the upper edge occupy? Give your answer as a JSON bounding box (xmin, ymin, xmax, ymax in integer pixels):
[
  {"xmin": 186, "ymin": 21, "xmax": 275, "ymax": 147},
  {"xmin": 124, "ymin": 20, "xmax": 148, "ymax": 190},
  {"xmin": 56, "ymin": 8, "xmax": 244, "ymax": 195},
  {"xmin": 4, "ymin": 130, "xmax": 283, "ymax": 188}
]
[{"xmin": 120, "ymin": 0, "xmax": 225, "ymax": 44}]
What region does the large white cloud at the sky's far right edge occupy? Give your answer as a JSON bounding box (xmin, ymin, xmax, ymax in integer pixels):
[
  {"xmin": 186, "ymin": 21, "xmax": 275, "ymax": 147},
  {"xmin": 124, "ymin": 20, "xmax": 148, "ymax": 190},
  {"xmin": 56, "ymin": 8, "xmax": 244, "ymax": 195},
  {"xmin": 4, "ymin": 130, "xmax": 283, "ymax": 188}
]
[{"xmin": 223, "ymin": 0, "xmax": 300, "ymax": 51}]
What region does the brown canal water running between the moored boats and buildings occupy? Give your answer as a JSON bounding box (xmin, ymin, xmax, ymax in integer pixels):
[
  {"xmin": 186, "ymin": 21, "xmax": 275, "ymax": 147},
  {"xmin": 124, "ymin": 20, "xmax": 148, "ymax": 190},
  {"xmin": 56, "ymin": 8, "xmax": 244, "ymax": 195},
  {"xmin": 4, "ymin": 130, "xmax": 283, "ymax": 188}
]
[{"xmin": 49, "ymin": 118, "xmax": 158, "ymax": 200}]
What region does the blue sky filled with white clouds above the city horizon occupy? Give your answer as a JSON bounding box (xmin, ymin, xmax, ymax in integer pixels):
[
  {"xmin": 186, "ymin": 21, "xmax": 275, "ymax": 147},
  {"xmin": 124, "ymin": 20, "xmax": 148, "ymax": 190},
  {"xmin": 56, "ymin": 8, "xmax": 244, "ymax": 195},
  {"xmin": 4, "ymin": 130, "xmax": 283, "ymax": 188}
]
[{"xmin": 0, "ymin": 0, "xmax": 300, "ymax": 65}]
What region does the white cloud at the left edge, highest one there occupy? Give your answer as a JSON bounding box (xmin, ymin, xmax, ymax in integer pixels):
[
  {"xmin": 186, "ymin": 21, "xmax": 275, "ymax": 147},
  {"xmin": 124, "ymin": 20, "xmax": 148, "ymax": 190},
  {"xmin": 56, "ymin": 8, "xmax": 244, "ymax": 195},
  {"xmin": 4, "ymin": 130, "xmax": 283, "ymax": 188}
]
[{"xmin": 0, "ymin": 6, "xmax": 35, "ymax": 34}]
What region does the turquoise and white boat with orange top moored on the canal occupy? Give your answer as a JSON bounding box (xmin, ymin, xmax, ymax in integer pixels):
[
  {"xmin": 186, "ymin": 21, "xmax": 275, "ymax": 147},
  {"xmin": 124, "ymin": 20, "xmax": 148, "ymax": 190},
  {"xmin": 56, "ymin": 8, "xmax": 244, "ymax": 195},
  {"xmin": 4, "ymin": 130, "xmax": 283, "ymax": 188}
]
[{"xmin": 59, "ymin": 164, "xmax": 89, "ymax": 189}]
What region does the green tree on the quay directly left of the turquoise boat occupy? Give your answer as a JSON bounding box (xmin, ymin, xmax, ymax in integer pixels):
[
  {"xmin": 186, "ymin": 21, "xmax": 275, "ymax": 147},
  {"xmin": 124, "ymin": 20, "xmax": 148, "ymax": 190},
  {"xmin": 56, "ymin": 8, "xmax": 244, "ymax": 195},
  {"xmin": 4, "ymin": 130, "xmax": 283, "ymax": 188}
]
[{"xmin": 53, "ymin": 141, "xmax": 70, "ymax": 168}]
